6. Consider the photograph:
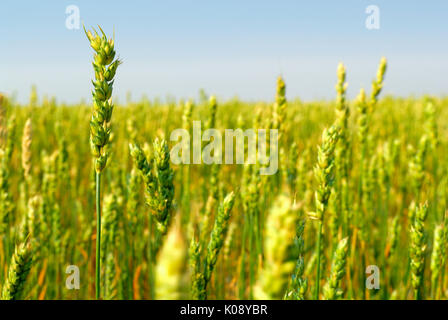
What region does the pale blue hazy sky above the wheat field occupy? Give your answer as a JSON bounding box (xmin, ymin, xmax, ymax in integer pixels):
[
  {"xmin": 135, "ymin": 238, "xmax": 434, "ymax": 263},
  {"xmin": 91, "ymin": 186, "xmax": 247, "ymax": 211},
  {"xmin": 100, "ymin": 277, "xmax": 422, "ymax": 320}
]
[{"xmin": 0, "ymin": 0, "xmax": 448, "ymax": 103}]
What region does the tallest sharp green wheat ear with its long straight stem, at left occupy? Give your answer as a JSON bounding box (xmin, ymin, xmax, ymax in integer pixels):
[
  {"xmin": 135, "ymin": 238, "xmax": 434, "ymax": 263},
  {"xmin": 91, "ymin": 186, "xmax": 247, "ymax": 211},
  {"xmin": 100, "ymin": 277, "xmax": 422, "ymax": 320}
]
[{"xmin": 84, "ymin": 27, "xmax": 121, "ymax": 299}]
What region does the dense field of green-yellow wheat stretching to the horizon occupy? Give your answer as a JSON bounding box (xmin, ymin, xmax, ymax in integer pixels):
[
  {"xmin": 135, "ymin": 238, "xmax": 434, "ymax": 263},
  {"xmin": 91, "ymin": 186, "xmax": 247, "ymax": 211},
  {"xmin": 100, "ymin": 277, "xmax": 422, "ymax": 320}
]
[{"xmin": 0, "ymin": 30, "xmax": 448, "ymax": 300}]
